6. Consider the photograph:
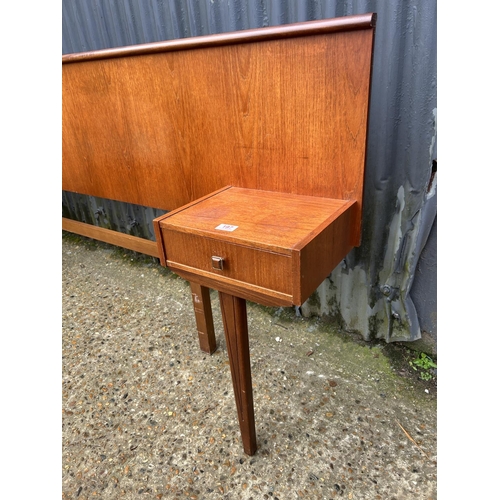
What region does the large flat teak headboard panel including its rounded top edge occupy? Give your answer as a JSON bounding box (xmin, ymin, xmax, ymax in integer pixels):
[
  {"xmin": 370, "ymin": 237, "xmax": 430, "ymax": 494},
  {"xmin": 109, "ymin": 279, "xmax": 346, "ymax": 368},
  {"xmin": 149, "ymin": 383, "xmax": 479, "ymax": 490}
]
[{"xmin": 62, "ymin": 14, "xmax": 375, "ymax": 244}]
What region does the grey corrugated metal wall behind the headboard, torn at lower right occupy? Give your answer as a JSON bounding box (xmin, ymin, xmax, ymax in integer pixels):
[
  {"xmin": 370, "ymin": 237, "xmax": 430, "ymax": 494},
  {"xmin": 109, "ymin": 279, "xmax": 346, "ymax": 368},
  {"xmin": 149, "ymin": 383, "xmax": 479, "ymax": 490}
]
[{"xmin": 62, "ymin": 0, "xmax": 437, "ymax": 342}]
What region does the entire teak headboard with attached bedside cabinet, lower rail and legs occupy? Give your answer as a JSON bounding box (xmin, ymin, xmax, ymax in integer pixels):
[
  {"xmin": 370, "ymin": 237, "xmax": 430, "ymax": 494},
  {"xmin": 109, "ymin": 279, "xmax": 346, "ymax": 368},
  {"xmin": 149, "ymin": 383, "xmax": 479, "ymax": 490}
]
[{"xmin": 62, "ymin": 14, "xmax": 375, "ymax": 455}]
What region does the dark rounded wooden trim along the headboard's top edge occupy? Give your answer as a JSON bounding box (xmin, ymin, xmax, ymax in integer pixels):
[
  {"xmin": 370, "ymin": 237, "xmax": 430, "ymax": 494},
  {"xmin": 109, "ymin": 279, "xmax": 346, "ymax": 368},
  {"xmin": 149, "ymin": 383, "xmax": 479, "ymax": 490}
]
[{"xmin": 62, "ymin": 13, "xmax": 377, "ymax": 64}]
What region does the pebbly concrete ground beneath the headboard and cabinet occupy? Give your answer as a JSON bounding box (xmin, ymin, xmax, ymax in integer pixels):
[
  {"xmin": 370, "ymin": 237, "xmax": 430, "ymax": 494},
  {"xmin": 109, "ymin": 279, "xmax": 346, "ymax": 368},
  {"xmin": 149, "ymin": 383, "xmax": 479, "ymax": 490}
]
[{"xmin": 62, "ymin": 233, "xmax": 437, "ymax": 500}]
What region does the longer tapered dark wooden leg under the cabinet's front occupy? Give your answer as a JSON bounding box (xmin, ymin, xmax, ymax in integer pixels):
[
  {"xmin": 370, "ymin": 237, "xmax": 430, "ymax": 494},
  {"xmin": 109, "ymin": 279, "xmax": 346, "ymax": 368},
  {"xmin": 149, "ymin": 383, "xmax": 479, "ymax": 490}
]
[{"xmin": 219, "ymin": 292, "xmax": 257, "ymax": 455}]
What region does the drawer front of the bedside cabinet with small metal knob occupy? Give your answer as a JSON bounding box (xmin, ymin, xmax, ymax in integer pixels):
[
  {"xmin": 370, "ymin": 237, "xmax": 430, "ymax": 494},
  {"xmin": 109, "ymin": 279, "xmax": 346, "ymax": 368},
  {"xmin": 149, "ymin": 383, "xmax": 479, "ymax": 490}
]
[{"xmin": 162, "ymin": 228, "xmax": 292, "ymax": 295}]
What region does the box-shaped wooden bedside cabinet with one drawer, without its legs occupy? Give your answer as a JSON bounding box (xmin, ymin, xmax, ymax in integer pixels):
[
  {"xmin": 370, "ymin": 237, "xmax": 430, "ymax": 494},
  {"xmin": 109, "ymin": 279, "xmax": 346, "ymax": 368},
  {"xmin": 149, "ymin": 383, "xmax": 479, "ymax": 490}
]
[{"xmin": 155, "ymin": 187, "xmax": 355, "ymax": 306}]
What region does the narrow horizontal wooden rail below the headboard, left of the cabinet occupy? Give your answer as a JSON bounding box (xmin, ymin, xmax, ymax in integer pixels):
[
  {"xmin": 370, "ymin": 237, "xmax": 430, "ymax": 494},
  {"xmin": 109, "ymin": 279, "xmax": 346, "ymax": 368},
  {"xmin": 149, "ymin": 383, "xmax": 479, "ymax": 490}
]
[{"xmin": 62, "ymin": 217, "xmax": 160, "ymax": 258}]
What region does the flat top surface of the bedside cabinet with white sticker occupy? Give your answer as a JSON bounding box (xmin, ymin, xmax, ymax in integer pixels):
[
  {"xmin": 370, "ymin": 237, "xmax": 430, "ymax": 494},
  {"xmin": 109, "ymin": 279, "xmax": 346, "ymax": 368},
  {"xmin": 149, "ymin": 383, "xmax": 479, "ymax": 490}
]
[{"xmin": 160, "ymin": 187, "xmax": 353, "ymax": 253}]
